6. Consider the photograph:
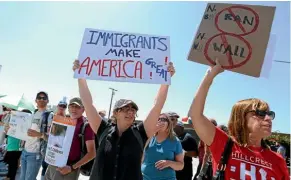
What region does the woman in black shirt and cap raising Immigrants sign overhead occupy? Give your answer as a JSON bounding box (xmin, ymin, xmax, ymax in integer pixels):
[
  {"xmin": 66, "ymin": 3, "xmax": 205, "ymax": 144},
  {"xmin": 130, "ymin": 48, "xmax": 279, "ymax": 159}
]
[{"xmin": 73, "ymin": 60, "xmax": 175, "ymax": 180}]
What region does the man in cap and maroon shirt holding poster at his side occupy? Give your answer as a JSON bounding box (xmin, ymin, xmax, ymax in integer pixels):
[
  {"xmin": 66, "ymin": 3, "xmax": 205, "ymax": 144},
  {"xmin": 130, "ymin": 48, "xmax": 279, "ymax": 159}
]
[{"xmin": 45, "ymin": 97, "xmax": 96, "ymax": 180}]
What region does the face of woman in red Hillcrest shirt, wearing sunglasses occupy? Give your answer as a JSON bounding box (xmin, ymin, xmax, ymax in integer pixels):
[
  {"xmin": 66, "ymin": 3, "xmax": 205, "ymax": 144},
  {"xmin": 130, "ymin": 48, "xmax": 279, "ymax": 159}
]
[{"xmin": 246, "ymin": 110, "xmax": 275, "ymax": 138}]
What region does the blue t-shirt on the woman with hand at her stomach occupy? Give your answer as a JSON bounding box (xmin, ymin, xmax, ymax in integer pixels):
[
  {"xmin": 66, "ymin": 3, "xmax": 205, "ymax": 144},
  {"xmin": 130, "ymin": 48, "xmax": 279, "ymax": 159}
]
[{"xmin": 141, "ymin": 137, "xmax": 183, "ymax": 180}]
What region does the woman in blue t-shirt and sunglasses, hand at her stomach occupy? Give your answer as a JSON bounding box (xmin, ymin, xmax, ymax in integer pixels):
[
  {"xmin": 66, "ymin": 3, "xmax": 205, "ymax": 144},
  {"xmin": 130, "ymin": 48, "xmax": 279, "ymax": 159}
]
[{"xmin": 141, "ymin": 114, "xmax": 184, "ymax": 180}]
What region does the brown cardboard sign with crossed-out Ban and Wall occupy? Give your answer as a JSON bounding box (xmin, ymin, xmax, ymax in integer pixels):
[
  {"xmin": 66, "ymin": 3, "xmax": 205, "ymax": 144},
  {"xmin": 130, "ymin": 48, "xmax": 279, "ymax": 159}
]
[{"xmin": 188, "ymin": 3, "xmax": 275, "ymax": 77}]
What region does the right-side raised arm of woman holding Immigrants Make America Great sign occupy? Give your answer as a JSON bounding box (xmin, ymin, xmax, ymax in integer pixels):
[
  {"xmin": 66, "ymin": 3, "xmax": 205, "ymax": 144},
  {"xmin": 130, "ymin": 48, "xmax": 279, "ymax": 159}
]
[{"xmin": 144, "ymin": 62, "xmax": 175, "ymax": 138}]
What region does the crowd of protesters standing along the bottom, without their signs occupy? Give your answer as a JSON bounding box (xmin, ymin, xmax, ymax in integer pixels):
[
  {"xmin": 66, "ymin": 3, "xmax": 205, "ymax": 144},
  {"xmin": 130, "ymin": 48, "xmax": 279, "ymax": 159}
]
[{"xmin": 0, "ymin": 60, "xmax": 290, "ymax": 180}]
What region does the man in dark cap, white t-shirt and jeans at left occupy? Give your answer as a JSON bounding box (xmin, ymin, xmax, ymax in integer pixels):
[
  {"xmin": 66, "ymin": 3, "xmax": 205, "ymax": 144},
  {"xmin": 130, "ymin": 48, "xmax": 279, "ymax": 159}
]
[{"xmin": 20, "ymin": 91, "xmax": 53, "ymax": 180}]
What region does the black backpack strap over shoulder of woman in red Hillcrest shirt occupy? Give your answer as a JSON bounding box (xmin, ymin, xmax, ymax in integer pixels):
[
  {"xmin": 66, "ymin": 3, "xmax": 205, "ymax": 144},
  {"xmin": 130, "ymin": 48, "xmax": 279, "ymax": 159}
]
[{"xmin": 213, "ymin": 137, "xmax": 233, "ymax": 180}]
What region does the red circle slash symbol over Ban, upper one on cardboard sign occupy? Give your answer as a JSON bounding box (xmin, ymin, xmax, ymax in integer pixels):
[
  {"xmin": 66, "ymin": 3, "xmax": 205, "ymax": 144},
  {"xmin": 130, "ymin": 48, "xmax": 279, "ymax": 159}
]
[{"xmin": 215, "ymin": 6, "xmax": 260, "ymax": 36}]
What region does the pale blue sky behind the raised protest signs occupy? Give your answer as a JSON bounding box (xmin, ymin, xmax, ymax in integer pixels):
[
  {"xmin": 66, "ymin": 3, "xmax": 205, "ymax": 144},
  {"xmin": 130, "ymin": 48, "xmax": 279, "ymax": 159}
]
[{"xmin": 0, "ymin": 2, "xmax": 290, "ymax": 132}]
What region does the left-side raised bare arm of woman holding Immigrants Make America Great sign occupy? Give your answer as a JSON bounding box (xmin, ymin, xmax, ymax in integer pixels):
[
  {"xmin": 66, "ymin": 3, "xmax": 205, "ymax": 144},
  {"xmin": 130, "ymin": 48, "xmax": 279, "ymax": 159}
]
[{"xmin": 73, "ymin": 60, "xmax": 102, "ymax": 134}]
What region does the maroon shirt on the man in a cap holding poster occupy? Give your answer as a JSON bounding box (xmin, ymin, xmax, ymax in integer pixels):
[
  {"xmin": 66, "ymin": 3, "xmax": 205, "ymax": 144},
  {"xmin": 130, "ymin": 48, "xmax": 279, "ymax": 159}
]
[{"xmin": 68, "ymin": 116, "xmax": 95, "ymax": 164}]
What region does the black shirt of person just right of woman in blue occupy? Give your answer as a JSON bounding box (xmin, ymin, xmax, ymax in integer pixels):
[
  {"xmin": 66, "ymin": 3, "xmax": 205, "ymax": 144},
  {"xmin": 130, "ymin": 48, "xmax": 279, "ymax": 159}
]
[{"xmin": 176, "ymin": 133, "xmax": 198, "ymax": 180}]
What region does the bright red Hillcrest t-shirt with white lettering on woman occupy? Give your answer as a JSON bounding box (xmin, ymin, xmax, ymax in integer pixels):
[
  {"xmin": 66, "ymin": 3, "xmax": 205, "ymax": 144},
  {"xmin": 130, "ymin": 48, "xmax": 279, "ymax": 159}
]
[{"xmin": 210, "ymin": 128, "xmax": 290, "ymax": 180}]
